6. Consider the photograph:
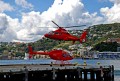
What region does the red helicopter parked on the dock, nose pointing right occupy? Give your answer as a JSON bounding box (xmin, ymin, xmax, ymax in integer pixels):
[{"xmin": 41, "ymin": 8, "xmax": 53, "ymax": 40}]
[{"xmin": 28, "ymin": 45, "xmax": 73, "ymax": 64}]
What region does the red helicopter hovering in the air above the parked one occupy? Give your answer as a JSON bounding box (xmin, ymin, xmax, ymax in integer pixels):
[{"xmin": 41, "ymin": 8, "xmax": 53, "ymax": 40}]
[{"xmin": 44, "ymin": 21, "xmax": 87, "ymax": 44}]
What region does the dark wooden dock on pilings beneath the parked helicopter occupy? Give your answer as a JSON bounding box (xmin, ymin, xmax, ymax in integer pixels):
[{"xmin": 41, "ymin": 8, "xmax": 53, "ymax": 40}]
[{"xmin": 0, "ymin": 64, "xmax": 114, "ymax": 81}]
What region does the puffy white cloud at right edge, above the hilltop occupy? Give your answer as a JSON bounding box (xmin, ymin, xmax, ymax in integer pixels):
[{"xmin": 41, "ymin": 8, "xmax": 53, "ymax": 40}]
[{"xmin": 100, "ymin": 0, "xmax": 120, "ymax": 23}]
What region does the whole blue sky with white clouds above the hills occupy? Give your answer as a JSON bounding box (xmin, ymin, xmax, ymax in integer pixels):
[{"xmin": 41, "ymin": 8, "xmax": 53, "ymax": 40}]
[{"xmin": 0, "ymin": 0, "xmax": 120, "ymax": 42}]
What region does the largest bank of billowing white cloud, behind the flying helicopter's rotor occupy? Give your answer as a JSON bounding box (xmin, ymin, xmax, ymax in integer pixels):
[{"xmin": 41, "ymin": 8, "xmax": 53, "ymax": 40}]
[{"xmin": 0, "ymin": 0, "xmax": 104, "ymax": 42}]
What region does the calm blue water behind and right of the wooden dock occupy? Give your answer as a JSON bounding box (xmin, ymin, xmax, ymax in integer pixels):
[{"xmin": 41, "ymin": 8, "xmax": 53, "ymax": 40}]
[{"xmin": 0, "ymin": 59, "xmax": 120, "ymax": 81}]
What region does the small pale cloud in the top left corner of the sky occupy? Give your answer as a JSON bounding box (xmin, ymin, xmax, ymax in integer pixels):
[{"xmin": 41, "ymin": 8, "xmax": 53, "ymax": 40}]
[{"xmin": 0, "ymin": 0, "xmax": 14, "ymax": 13}]
